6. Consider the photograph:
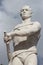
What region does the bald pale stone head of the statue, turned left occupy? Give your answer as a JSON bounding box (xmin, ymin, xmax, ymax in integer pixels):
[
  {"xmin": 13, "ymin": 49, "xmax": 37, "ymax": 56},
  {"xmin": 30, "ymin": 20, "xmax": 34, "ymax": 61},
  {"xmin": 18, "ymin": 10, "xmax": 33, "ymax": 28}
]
[{"xmin": 20, "ymin": 5, "xmax": 32, "ymax": 20}]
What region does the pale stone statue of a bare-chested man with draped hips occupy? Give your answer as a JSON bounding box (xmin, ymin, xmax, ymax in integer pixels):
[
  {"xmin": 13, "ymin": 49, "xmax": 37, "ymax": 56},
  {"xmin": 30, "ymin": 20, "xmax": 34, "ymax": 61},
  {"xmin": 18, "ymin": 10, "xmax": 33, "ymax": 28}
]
[{"xmin": 4, "ymin": 5, "xmax": 41, "ymax": 65}]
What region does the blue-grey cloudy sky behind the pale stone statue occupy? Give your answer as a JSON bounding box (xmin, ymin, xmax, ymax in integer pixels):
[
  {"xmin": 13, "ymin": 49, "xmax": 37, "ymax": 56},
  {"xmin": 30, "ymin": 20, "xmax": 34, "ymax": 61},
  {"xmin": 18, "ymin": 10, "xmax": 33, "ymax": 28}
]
[{"xmin": 0, "ymin": 0, "xmax": 43, "ymax": 65}]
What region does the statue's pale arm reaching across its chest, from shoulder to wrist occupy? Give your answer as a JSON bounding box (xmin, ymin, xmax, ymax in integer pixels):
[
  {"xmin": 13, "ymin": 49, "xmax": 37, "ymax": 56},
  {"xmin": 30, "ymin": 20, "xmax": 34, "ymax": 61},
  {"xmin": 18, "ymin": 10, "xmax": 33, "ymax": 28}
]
[{"xmin": 8, "ymin": 22, "xmax": 41, "ymax": 37}]
